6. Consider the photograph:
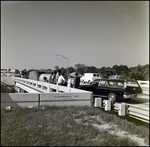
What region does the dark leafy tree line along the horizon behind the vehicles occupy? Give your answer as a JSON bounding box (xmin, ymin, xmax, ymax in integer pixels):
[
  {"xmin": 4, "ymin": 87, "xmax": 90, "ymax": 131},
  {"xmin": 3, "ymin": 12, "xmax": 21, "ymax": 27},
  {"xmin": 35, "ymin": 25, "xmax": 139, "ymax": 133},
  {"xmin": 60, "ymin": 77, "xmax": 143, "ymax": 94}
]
[{"xmin": 7, "ymin": 63, "xmax": 149, "ymax": 81}]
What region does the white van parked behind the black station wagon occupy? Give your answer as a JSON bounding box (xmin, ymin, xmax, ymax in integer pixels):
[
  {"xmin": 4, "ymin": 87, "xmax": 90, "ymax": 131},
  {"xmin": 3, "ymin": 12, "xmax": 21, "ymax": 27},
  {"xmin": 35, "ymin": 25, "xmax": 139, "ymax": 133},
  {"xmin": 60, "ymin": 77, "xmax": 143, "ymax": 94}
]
[{"xmin": 81, "ymin": 73, "xmax": 101, "ymax": 84}]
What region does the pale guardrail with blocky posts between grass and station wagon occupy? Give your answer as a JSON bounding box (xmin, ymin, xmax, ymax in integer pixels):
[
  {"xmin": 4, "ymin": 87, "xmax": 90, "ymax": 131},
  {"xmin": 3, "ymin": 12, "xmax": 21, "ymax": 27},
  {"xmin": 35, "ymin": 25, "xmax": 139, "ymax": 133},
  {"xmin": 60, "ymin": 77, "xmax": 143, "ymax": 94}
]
[{"xmin": 94, "ymin": 98, "xmax": 149, "ymax": 123}]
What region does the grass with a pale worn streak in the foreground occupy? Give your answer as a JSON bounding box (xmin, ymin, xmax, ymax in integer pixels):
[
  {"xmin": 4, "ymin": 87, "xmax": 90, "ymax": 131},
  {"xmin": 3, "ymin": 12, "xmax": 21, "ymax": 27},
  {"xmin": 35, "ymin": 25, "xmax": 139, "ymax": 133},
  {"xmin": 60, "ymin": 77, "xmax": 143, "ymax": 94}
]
[{"xmin": 1, "ymin": 106, "xmax": 149, "ymax": 146}]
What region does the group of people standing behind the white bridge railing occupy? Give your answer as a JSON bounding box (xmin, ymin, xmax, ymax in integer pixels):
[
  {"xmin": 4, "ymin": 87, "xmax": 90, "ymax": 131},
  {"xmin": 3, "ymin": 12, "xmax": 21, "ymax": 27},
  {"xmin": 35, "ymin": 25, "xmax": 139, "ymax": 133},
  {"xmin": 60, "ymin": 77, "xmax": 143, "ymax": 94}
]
[{"xmin": 48, "ymin": 70, "xmax": 80, "ymax": 88}]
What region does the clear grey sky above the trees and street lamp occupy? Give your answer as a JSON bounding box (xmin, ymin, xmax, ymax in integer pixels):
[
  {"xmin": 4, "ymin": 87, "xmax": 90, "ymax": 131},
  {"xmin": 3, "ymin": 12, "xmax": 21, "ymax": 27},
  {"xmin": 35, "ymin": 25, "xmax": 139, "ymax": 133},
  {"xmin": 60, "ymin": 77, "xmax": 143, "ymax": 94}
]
[{"xmin": 1, "ymin": 1, "xmax": 149, "ymax": 70}]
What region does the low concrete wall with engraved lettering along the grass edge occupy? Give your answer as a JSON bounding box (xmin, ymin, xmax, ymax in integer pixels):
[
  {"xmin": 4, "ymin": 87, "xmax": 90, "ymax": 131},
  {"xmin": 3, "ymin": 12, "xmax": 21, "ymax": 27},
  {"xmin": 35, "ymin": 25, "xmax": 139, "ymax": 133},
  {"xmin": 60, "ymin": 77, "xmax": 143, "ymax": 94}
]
[{"xmin": 1, "ymin": 92, "xmax": 93, "ymax": 108}]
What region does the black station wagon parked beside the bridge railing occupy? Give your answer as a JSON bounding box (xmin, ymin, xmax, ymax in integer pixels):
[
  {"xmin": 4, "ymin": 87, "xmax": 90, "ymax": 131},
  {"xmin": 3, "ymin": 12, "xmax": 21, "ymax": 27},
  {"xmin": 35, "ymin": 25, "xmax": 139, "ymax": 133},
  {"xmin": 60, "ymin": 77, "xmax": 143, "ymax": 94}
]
[{"xmin": 80, "ymin": 79, "xmax": 143, "ymax": 102}]
